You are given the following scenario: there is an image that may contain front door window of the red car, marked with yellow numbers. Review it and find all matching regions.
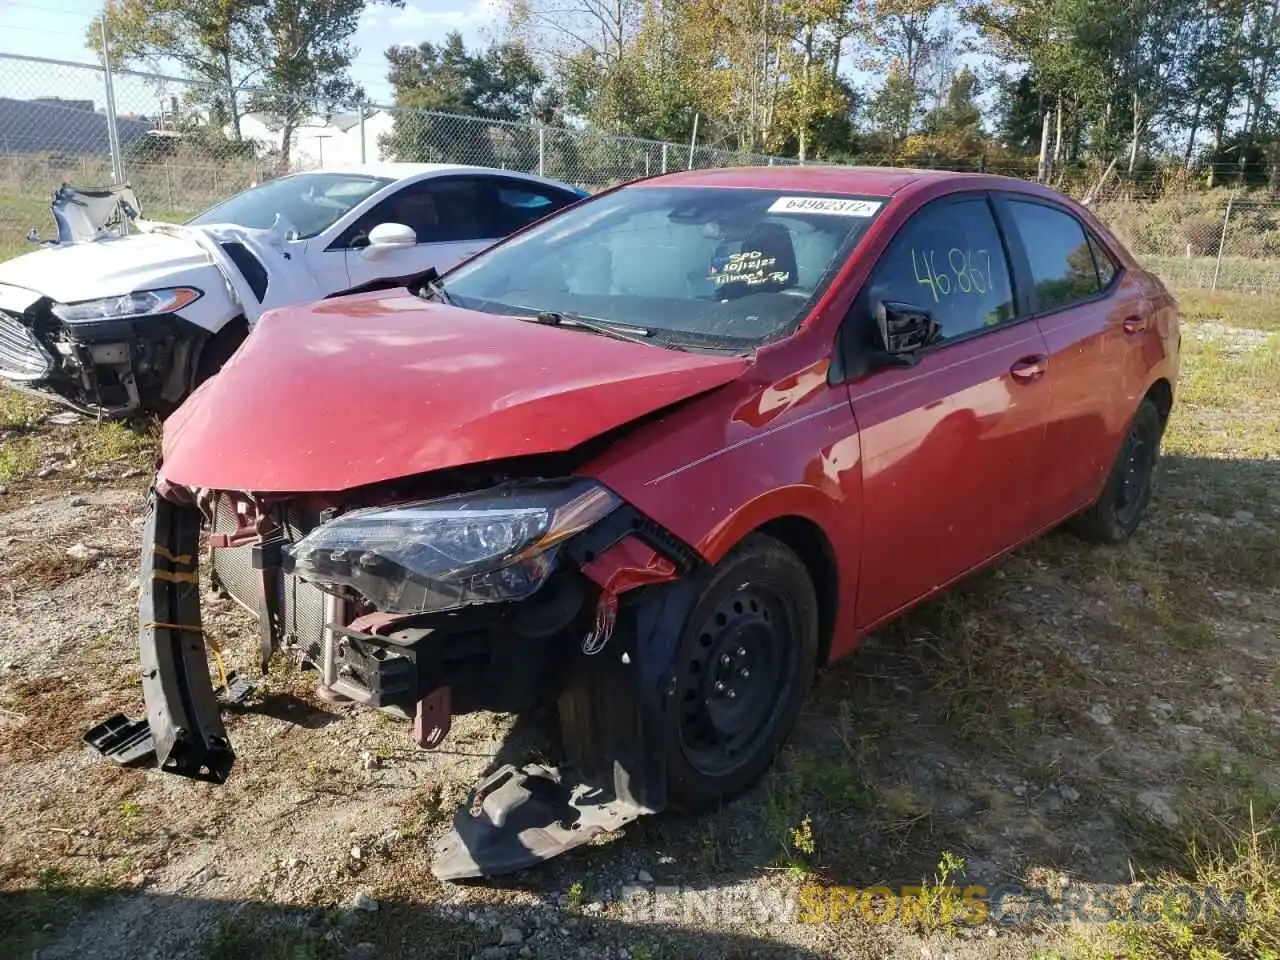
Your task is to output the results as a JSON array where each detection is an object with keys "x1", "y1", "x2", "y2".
[{"x1": 867, "y1": 196, "x2": 1014, "y2": 340}]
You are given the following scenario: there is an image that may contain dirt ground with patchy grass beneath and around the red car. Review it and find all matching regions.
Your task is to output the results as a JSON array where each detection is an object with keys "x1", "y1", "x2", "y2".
[{"x1": 0, "y1": 296, "x2": 1280, "y2": 960}]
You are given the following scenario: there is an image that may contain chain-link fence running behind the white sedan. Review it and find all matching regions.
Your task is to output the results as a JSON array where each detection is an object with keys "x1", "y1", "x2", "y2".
[{"x1": 0, "y1": 54, "x2": 797, "y2": 259}]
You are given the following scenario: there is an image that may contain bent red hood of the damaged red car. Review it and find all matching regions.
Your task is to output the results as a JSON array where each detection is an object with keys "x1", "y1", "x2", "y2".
[{"x1": 163, "y1": 292, "x2": 749, "y2": 493}]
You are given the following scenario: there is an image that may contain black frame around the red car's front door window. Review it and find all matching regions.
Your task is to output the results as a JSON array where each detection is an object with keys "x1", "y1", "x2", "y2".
[{"x1": 832, "y1": 189, "x2": 1034, "y2": 383}]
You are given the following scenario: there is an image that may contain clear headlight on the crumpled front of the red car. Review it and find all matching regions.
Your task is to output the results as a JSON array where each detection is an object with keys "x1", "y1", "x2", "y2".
[{"x1": 284, "y1": 480, "x2": 621, "y2": 613}]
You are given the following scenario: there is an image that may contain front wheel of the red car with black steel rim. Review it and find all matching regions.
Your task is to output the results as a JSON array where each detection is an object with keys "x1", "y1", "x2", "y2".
[{"x1": 666, "y1": 534, "x2": 818, "y2": 812}]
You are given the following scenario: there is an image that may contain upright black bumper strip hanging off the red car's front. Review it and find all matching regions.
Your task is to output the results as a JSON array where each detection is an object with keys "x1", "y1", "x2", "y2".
[{"x1": 138, "y1": 490, "x2": 236, "y2": 783}]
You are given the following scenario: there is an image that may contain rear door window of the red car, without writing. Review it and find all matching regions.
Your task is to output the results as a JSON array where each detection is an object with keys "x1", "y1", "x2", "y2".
[{"x1": 1006, "y1": 200, "x2": 1102, "y2": 312}]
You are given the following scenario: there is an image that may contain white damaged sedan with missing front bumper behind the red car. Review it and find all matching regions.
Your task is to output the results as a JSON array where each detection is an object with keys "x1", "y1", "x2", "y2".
[{"x1": 0, "y1": 164, "x2": 586, "y2": 417}]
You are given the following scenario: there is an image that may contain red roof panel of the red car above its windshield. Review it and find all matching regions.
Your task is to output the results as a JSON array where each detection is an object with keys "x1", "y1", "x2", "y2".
[{"x1": 637, "y1": 165, "x2": 1021, "y2": 197}]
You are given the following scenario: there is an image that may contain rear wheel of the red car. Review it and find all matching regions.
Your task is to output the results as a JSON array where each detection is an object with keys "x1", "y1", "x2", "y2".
[{"x1": 1068, "y1": 398, "x2": 1164, "y2": 544}]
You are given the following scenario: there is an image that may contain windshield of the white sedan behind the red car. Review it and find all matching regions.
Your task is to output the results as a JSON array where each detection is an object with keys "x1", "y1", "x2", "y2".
[{"x1": 187, "y1": 173, "x2": 394, "y2": 239}]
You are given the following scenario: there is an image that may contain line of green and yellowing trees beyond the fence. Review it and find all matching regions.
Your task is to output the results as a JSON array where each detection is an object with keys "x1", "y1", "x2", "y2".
[{"x1": 90, "y1": 0, "x2": 1280, "y2": 188}]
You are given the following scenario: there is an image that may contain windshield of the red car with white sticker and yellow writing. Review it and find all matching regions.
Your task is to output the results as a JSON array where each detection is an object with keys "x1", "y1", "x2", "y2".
[{"x1": 443, "y1": 186, "x2": 883, "y2": 348}]
